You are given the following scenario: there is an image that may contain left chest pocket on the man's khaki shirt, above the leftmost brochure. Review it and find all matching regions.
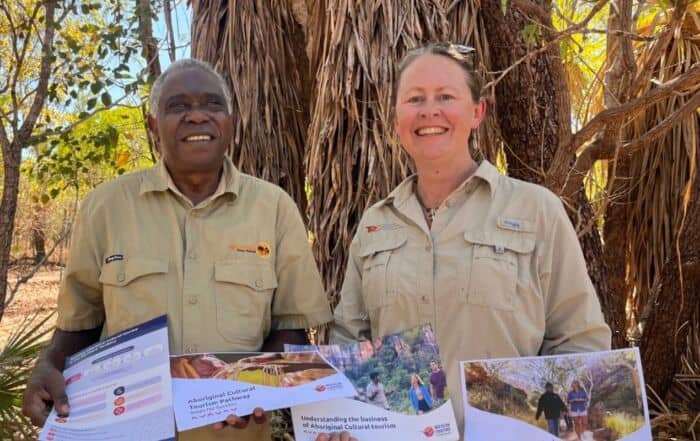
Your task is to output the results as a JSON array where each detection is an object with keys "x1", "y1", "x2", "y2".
[{"x1": 99, "y1": 257, "x2": 168, "y2": 333}]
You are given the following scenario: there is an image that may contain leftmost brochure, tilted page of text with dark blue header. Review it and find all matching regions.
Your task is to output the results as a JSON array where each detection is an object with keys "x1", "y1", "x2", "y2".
[{"x1": 39, "y1": 316, "x2": 175, "y2": 441}]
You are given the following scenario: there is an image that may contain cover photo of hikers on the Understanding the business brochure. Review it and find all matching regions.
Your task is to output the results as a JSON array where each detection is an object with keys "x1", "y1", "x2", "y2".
[{"x1": 285, "y1": 325, "x2": 449, "y2": 415}]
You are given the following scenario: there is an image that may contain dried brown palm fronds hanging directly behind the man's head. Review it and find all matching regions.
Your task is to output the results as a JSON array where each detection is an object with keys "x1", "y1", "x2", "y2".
[{"x1": 191, "y1": 0, "x2": 308, "y2": 210}]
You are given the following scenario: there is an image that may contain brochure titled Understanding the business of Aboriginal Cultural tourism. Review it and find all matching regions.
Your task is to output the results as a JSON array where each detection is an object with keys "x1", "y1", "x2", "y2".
[{"x1": 285, "y1": 325, "x2": 459, "y2": 441}]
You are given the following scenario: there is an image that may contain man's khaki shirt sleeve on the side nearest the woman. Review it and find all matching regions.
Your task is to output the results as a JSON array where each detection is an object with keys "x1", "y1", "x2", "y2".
[{"x1": 272, "y1": 193, "x2": 333, "y2": 330}]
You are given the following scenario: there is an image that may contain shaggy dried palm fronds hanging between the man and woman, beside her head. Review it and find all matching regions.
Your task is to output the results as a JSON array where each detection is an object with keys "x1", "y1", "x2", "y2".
[{"x1": 306, "y1": 0, "x2": 449, "y2": 305}]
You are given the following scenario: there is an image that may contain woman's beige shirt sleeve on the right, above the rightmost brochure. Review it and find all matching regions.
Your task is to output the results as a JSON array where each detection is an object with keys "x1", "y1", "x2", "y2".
[{"x1": 539, "y1": 195, "x2": 611, "y2": 354}]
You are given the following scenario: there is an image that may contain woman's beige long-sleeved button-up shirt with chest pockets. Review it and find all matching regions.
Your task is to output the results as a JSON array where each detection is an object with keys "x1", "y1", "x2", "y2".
[{"x1": 331, "y1": 161, "x2": 610, "y2": 431}]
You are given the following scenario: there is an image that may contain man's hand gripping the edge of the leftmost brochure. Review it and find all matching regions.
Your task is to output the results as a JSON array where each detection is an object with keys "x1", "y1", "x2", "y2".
[{"x1": 22, "y1": 360, "x2": 70, "y2": 427}]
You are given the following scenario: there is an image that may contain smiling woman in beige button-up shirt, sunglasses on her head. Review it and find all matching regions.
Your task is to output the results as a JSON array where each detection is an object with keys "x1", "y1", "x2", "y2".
[{"x1": 320, "y1": 44, "x2": 610, "y2": 440}]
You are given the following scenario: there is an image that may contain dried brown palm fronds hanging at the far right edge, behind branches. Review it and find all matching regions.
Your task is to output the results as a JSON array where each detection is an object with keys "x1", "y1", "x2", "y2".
[{"x1": 625, "y1": 6, "x2": 700, "y2": 336}]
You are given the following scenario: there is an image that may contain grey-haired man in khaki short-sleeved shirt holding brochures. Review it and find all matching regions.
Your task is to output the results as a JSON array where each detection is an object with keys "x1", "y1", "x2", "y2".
[{"x1": 23, "y1": 60, "x2": 331, "y2": 441}]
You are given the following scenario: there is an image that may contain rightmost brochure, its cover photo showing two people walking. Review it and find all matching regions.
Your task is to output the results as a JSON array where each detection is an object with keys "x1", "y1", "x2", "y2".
[{"x1": 460, "y1": 348, "x2": 652, "y2": 441}]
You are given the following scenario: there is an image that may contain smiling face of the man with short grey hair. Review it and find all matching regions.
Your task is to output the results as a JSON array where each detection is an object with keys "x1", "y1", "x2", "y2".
[{"x1": 148, "y1": 67, "x2": 233, "y2": 179}]
